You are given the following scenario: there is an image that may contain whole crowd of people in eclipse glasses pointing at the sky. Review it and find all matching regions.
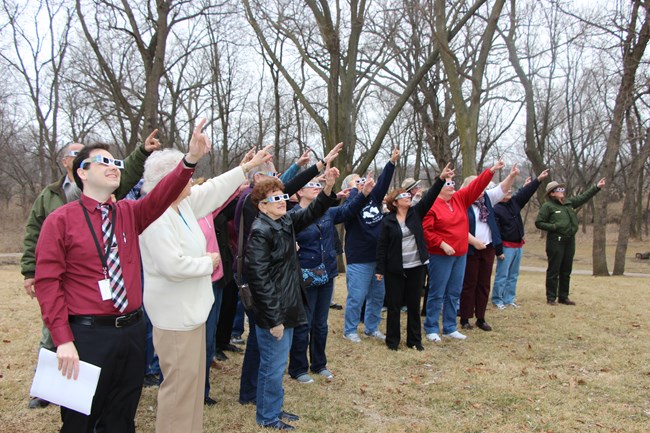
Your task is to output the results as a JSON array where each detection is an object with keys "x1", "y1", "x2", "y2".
[{"x1": 21, "y1": 121, "x2": 605, "y2": 433}]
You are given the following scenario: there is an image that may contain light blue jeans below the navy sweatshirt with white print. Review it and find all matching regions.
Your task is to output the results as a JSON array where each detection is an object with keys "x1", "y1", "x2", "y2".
[{"x1": 343, "y1": 260, "x2": 385, "y2": 335}]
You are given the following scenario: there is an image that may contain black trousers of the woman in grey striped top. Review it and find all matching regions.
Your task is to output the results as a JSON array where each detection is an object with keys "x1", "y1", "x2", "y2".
[{"x1": 384, "y1": 266, "x2": 427, "y2": 348}]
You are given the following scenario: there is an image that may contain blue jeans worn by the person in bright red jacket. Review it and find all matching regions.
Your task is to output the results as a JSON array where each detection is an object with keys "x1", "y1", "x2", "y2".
[{"x1": 424, "y1": 254, "x2": 467, "y2": 334}]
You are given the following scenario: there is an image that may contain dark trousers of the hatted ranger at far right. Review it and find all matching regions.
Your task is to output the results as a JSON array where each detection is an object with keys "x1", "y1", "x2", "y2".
[{"x1": 546, "y1": 233, "x2": 576, "y2": 301}]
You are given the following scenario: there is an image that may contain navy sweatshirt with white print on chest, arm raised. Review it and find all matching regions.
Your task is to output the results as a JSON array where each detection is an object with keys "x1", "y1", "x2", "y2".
[{"x1": 345, "y1": 161, "x2": 395, "y2": 264}]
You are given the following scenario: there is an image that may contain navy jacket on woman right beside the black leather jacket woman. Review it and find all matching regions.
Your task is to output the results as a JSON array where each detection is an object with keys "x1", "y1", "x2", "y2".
[{"x1": 290, "y1": 190, "x2": 368, "y2": 280}]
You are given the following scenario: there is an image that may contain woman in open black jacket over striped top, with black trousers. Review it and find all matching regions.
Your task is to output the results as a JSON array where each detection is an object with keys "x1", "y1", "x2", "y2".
[{"x1": 376, "y1": 164, "x2": 454, "y2": 351}]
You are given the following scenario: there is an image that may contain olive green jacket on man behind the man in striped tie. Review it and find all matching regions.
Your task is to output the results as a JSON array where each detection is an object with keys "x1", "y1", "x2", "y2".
[{"x1": 20, "y1": 146, "x2": 150, "y2": 278}]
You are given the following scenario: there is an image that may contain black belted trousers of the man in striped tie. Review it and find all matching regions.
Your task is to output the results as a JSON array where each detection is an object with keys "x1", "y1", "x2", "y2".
[{"x1": 61, "y1": 316, "x2": 147, "y2": 433}]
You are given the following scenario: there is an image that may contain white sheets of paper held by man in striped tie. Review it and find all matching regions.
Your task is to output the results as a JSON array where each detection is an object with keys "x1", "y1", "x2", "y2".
[{"x1": 29, "y1": 348, "x2": 102, "y2": 415}]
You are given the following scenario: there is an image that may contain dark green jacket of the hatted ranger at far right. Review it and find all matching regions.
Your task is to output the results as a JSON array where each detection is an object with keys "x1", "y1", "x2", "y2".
[{"x1": 535, "y1": 185, "x2": 600, "y2": 236}]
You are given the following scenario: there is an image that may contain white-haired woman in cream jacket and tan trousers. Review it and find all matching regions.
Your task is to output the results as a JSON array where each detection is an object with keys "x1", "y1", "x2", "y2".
[{"x1": 140, "y1": 149, "x2": 270, "y2": 433}]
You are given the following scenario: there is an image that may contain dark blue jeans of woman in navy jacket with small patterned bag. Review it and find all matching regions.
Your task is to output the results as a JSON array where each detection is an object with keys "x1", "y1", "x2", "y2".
[{"x1": 289, "y1": 279, "x2": 334, "y2": 379}]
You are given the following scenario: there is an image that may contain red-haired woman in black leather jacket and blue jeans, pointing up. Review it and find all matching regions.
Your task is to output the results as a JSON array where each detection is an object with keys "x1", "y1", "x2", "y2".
[{"x1": 246, "y1": 168, "x2": 339, "y2": 430}]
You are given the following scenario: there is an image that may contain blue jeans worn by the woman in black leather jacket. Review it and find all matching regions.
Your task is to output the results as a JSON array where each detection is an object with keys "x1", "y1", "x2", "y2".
[{"x1": 256, "y1": 326, "x2": 293, "y2": 425}]
